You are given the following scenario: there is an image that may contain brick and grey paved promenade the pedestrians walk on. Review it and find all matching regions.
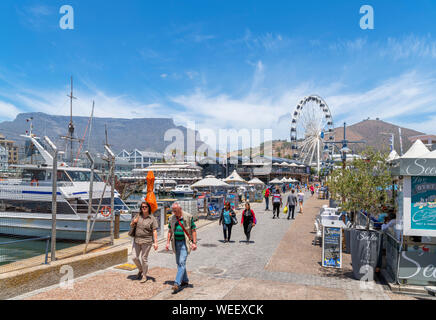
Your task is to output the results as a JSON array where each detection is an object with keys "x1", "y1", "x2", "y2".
[{"x1": 13, "y1": 192, "x2": 416, "y2": 300}]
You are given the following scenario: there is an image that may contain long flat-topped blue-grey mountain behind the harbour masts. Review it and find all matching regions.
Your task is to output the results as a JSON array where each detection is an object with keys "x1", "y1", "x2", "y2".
[{"x1": 0, "y1": 112, "x2": 201, "y2": 153}]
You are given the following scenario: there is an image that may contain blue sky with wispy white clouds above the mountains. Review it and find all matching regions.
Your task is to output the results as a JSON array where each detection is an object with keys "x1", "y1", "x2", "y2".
[{"x1": 0, "y1": 0, "x2": 436, "y2": 148}]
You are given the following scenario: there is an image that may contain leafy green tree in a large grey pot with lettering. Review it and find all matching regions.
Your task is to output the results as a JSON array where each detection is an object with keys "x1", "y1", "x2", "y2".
[{"x1": 329, "y1": 149, "x2": 391, "y2": 279}]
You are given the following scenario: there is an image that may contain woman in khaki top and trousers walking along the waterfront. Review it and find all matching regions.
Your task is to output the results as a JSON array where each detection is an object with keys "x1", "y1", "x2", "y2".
[{"x1": 129, "y1": 201, "x2": 158, "y2": 281}]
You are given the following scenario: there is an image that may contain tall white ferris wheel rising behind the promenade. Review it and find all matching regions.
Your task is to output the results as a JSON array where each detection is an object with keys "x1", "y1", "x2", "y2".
[{"x1": 291, "y1": 95, "x2": 335, "y2": 172}]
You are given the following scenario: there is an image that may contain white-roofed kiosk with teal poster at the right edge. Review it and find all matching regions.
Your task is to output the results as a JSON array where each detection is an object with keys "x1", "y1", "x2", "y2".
[{"x1": 386, "y1": 140, "x2": 436, "y2": 286}]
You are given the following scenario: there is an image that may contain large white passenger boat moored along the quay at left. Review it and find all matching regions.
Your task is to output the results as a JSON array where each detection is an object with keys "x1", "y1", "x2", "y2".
[{"x1": 0, "y1": 134, "x2": 131, "y2": 240}]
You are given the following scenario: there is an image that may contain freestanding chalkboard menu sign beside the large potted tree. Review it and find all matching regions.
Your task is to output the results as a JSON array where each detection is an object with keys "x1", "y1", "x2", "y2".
[{"x1": 322, "y1": 226, "x2": 342, "y2": 268}]
